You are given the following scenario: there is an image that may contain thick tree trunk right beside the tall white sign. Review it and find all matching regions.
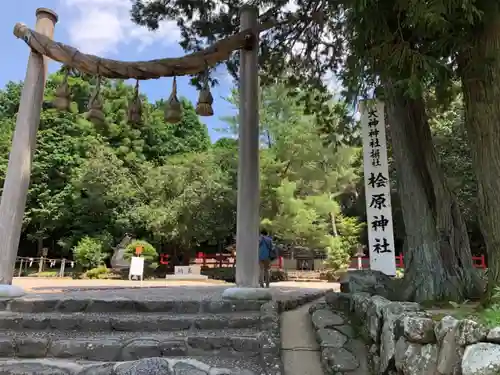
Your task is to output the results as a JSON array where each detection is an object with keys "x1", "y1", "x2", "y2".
[{"x1": 386, "y1": 89, "x2": 482, "y2": 302}]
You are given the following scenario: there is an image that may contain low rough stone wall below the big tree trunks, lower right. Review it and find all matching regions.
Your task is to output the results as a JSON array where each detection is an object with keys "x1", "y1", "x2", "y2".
[{"x1": 326, "y1": 293, "x2": 500, "y2": 375}]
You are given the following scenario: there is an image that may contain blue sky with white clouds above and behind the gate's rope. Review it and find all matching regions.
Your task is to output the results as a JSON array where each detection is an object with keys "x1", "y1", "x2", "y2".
[{"x1": 0, "y1": 0, "x2": 235, "y2": 140}]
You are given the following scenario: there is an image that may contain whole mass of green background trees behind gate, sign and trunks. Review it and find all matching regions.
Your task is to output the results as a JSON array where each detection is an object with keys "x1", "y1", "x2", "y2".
[{"x1": 0, "y1": 69, "x2": 482, "y2": 280}]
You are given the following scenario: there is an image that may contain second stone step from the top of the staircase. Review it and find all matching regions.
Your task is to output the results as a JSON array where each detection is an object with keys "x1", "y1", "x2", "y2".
[{"x1": 0, "y1": 311, "x2": 260, "y2": 332}]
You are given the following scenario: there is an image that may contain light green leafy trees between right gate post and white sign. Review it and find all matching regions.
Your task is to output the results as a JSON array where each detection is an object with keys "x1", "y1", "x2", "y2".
[{"x1": 226, "y1": 84, "x2": 363, "y2": 269}]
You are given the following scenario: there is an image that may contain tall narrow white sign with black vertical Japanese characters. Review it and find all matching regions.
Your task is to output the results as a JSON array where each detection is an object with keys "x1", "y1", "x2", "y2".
[{"x1": 360, "y1": 100, "x2": 396, "y2": 276}]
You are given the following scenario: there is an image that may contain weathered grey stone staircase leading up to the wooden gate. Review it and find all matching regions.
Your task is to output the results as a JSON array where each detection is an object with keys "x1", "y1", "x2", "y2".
[{"x1": 0, "y1": 294, "x2": 279, "y2": 375}]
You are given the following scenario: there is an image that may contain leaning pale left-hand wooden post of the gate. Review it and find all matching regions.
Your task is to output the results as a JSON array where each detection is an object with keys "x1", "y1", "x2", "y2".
[{"x1": 0, "y1": 8, "x2": 57, "y2": 284}]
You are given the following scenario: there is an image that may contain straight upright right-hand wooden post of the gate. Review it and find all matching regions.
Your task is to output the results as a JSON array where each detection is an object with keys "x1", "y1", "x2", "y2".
[{"x1": 236, "y1": 5, "x2": 260, "y2": 288}]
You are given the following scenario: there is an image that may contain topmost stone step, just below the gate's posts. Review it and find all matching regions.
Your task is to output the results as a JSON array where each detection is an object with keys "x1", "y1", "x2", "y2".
[{"x1": 0, "y1": 294, "x2": 265, "y2": 314}]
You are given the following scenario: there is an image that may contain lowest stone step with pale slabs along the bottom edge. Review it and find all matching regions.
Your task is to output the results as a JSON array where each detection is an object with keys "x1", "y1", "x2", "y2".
[{"x1": 0, "y1": 356, "x2": 266, "y2": 375}]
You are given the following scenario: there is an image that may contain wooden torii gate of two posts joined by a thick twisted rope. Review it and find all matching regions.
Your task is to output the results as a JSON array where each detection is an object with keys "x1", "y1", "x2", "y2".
[{"x1": 0, "y1": 6, "x2": 277, "y2": 298}]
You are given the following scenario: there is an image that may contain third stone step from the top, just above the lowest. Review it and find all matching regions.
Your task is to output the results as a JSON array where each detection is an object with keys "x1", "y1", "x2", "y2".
[{"x1": 0, "y1": 329, "x2": 265, "y2": 362}]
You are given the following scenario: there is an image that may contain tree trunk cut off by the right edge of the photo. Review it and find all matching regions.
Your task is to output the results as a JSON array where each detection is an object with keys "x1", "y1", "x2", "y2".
[{"x1": 458, "y1": 15, "x2": 500, "y2": 299}]
